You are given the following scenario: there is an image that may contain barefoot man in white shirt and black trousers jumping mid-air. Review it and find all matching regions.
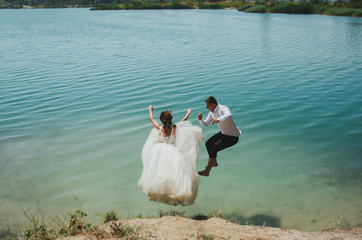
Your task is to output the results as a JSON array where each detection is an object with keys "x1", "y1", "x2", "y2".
[{"x1": 197, "y1": 97, "x2": 241, "y2": 177}]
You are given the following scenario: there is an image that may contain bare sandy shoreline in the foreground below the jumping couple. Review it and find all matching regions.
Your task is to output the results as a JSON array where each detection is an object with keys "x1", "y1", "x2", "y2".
[{"x1": 59, "y1": 216, "x2": 362, "y2": 240}]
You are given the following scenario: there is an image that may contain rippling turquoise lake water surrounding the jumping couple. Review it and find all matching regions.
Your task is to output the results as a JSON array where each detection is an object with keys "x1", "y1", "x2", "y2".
[{"x1": 0, "y1": 9, "x2": 362, "y2": 231}]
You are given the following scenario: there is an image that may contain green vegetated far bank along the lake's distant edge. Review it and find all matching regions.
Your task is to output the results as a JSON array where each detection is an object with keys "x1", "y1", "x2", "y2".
[{"x1": 0, "y1": 0, "x2": 362, "y2": 17}]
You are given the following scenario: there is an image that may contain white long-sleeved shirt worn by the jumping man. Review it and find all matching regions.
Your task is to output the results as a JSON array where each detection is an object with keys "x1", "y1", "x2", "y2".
[{"x1": 199, "y1": 104, "x2": 241, "y2": 137}]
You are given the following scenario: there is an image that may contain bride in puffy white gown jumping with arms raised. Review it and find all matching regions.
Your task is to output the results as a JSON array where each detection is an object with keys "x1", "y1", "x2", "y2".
[{"x1": 138, "y1": 105, "x2": 204, "y2": 206}]
